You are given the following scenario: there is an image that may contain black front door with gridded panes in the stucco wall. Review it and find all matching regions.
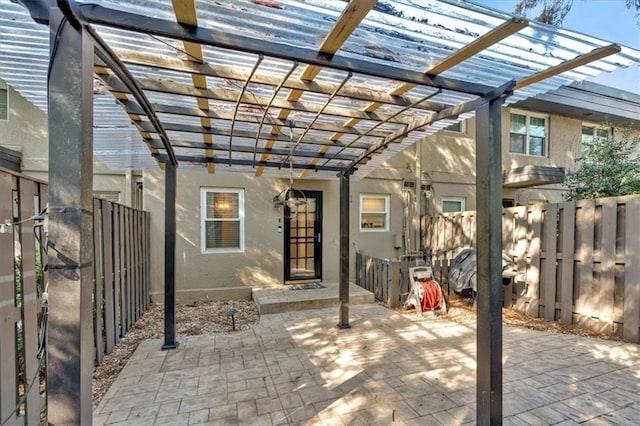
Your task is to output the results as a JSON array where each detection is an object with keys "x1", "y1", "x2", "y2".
[{"x1": 284, "y1": 191, "x2": 322, "y2": 283}]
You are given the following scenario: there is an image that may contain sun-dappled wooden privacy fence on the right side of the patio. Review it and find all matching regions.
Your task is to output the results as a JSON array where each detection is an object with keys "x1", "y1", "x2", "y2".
[{"x1": 421, "y1": 195, "x2": 640, "y2": 343}]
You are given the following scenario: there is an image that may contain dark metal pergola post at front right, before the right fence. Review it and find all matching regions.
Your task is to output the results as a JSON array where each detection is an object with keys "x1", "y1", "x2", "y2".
[{"x1": 476, "y1": 97, "x2": 503, "y2": 425}]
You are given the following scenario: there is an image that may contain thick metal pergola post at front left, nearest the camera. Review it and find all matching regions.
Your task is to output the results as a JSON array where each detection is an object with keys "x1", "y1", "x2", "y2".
[{"x1": 47, "y1": 7, "x2": 94, "y2": 425}]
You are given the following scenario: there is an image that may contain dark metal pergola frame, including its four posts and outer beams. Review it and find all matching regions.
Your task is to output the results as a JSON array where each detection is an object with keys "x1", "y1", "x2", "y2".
[{"x1": 20, "y1": 0, "x2": 604, "y2": 424}]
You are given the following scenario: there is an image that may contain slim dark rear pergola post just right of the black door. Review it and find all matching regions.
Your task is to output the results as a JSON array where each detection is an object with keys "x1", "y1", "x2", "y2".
[{"x1": 338, "y1": 173, "x2": 351, "y2": 329}]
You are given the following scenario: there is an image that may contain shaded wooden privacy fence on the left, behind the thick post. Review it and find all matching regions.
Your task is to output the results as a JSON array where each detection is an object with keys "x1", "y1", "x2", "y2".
[{"x1": 0, "y1": 169, "x2": 149, "y2": 425}]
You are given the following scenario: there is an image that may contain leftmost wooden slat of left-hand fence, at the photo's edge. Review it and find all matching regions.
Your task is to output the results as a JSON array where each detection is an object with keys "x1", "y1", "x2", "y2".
[{"x1": 0, "y1": 173, "x2": 20, "y2": 425}]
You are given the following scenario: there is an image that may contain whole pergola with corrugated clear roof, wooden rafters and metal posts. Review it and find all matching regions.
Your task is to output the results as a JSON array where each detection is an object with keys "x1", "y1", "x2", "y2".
[{"x1": 5, "y1": 0, "x2": 640, "y2": 424}]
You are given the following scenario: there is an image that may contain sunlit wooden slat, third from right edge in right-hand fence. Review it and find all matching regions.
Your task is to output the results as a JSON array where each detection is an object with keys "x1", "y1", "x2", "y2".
[{"x1": 576, "y1": 200, "x2": 596, "y2": 327}]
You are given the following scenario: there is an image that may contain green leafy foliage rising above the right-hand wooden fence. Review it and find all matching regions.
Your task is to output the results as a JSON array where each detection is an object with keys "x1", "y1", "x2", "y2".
[{"x1": 565, "y1": 129, "x2": 640, "y2": 200}]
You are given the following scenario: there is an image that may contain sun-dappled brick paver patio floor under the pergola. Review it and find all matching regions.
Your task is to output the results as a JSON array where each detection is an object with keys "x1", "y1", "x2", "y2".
[{"x1": 94, "y1": 304, "x2": 640, "y2": 425}]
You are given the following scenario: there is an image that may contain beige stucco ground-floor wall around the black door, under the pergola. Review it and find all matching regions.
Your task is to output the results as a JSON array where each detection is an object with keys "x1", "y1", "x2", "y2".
[{"x1": 144, "y1": 162, "x2": 412, "y2": 301}]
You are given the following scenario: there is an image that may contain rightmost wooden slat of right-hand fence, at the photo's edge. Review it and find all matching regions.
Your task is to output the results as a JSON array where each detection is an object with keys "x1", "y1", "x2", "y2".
[{"x1": 622, "y1": 197, "x2": 640, "y2": 343}]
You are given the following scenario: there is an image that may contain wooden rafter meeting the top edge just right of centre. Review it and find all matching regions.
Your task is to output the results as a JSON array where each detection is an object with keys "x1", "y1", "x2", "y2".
[{"x1": 256, "y1": 0, "x2": 376, "y2": 176}]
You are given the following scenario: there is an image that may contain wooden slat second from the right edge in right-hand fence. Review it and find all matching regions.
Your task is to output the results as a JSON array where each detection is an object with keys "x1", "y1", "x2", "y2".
[{"x1": 598, "y1": 198, "x2": 617, "y2": 331}]
